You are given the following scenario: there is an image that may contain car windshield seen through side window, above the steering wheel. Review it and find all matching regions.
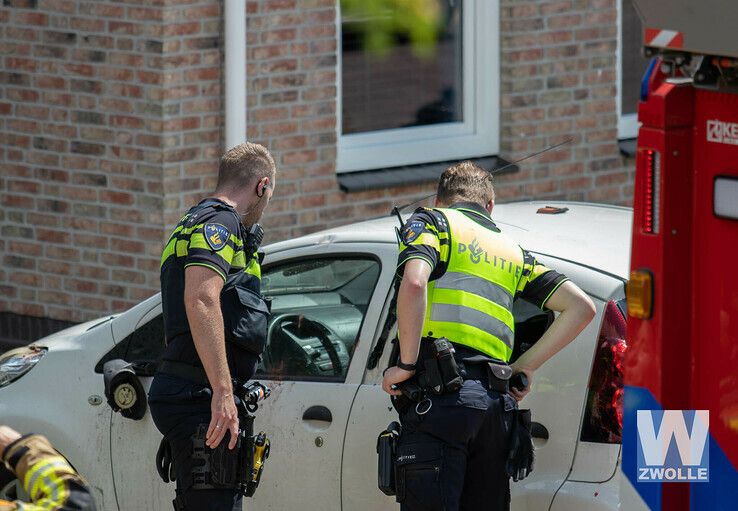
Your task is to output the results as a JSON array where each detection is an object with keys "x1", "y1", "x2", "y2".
[{"x1": 261, "y1": 259, "x2": 375, "y2": 297}]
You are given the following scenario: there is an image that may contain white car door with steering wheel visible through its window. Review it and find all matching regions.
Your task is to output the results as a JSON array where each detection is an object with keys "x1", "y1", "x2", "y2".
[{"x1": 247, "y1": 243, "x2": 396, "y2": 511}]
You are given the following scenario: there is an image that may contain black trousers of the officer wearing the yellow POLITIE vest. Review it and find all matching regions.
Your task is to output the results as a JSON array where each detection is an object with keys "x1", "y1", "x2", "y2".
[{"x1": 395, "y1": 380, "x2": 516, "y2": 511}]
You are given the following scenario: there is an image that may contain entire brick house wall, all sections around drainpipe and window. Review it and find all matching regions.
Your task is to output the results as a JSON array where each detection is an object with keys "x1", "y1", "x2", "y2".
[{"x1": 0, "y1": 0, "x2": 632, "y2": 328}]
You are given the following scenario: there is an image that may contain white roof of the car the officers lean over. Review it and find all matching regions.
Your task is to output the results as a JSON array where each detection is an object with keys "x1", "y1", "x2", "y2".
[{"x1": 265, "y1": 201, "x2": 633, "y2": 279}]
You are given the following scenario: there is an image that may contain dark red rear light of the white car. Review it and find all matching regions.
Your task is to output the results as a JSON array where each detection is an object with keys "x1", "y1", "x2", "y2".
[{"x1": 580, "y1": 300, "x2": 628, "y2": 443}]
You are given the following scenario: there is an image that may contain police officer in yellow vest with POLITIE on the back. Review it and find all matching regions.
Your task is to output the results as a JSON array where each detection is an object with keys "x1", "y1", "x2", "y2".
[{"x1": 382, "y1": 161, "x2": 595, "y2": 511}]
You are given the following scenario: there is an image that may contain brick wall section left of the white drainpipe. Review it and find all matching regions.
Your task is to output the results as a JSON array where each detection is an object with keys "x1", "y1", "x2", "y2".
[{"x1": 0, "y1": 0, "x2": 222, "y2": 321}]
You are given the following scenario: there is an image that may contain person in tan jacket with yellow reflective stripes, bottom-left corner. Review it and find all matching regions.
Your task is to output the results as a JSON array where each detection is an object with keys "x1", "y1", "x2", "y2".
[{"x1": 0, "y1": 426, "x2": 95, "y2": 511}]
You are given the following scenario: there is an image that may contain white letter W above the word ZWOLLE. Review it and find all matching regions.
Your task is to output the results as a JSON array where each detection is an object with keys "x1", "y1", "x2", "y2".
[{"x1": 637, "y1": 410, "x2": 710, "y2": 466}]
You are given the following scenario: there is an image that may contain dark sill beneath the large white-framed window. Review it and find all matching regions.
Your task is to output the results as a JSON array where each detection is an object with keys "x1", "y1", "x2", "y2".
[{"x1": 338, "y1": 156, "x2": 519, "y2": 193}]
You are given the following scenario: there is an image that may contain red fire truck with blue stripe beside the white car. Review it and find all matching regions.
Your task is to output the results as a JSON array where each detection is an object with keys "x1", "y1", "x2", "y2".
[{"x1": 621, "y1": 0, "x2": 738, "y2": 511}]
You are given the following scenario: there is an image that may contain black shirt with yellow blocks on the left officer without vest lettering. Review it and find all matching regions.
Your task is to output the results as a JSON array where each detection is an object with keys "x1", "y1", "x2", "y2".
[{"x1": 161, "y1": 198, "x2": 254, "y2": 374}]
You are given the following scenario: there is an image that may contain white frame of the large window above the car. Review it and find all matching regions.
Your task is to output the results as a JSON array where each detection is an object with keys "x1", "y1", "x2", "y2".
[{"x1": 336, "y1": 0, "x2": 500, "y2": 173}]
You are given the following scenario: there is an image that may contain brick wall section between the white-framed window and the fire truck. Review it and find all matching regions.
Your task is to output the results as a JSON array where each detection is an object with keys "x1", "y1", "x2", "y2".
[{"x1": 498, "y1": 0, "x2": 634, "y2": 204}]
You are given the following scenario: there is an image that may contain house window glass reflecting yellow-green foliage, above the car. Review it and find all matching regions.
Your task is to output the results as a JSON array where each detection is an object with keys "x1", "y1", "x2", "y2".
[{"x1": 341, "y1": 0, "x2": 463, "y2": 135}]
